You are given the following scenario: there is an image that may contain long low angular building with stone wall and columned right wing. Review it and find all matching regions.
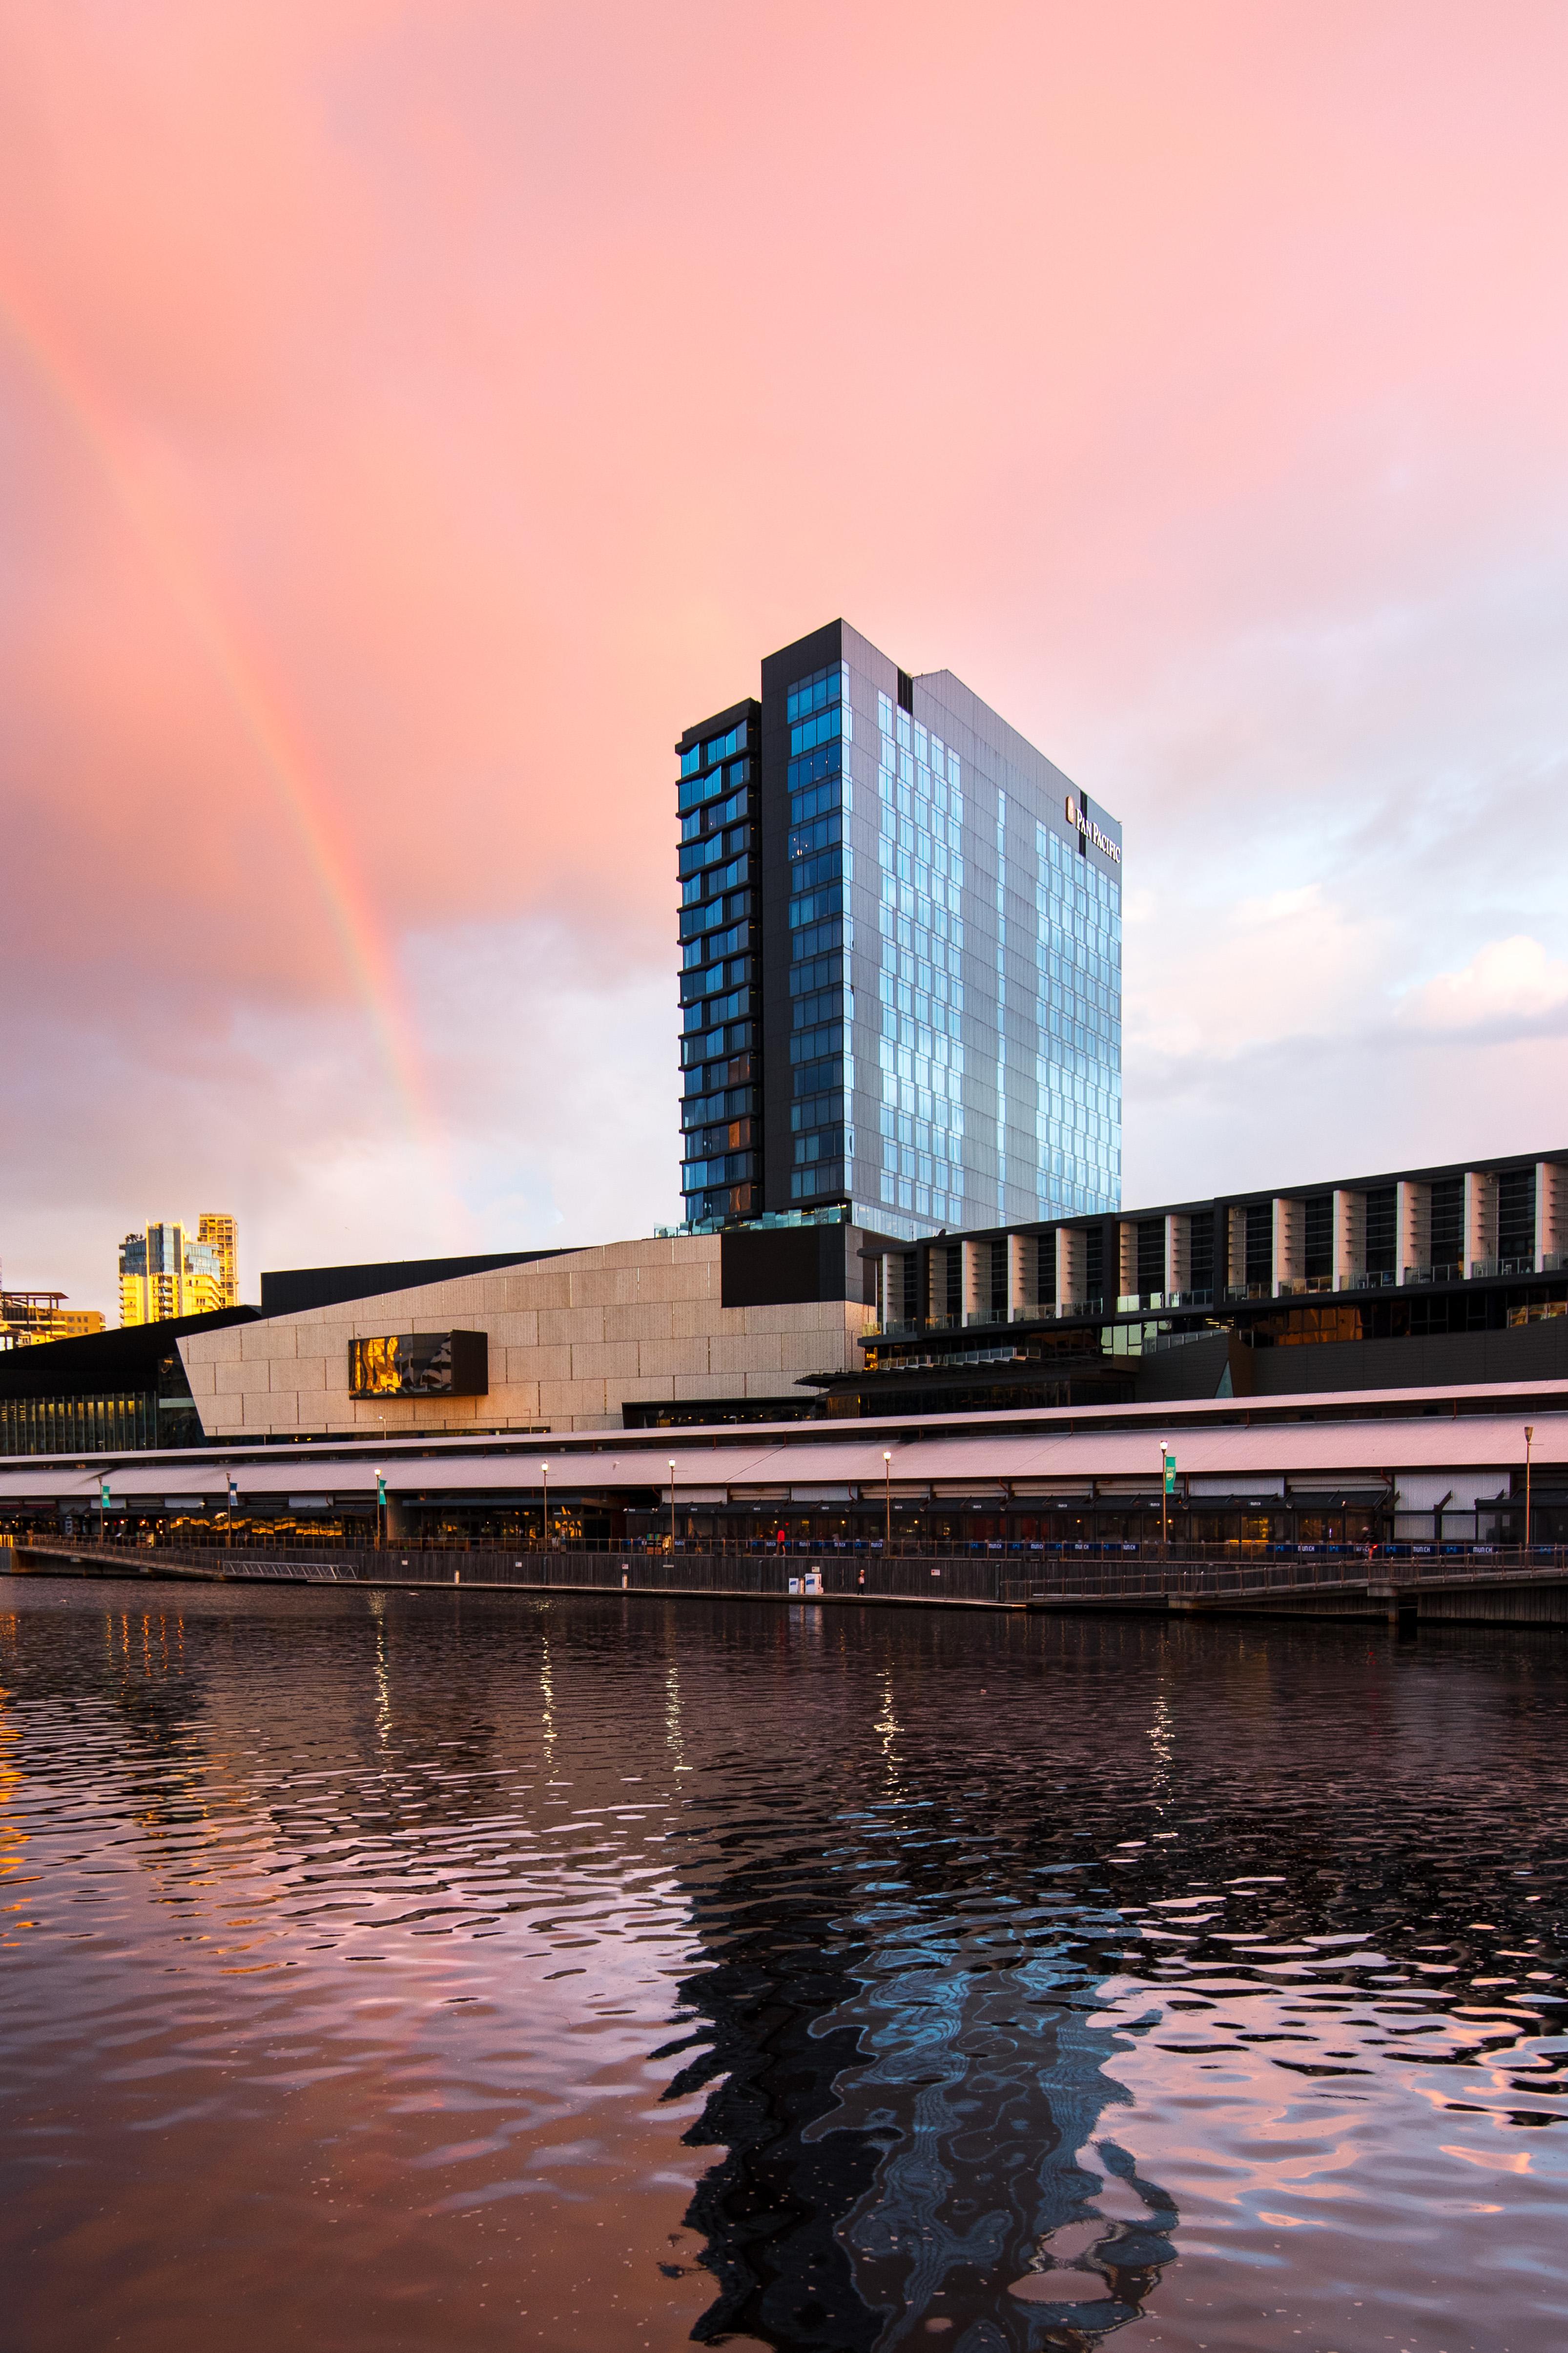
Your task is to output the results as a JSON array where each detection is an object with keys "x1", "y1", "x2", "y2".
[{"x1": 0, "y1": 1150, "x2": 1568, "y2": 1454}]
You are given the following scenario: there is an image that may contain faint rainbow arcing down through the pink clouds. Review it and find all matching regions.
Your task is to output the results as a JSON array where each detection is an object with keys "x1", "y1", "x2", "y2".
[{"x1": 0, "y1": 261, "x2": 447, "y2": 1169}]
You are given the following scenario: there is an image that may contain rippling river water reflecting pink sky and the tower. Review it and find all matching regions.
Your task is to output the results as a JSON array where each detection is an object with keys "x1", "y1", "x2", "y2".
[{"x1": 0, "y1": 1579, "x2": 1568, "y2": 2353}]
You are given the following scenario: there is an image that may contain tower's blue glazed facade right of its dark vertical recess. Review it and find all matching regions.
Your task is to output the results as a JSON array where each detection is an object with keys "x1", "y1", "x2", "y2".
[{"x1": 787, "y1": 628, "x2": 1121, "y2": 1238}]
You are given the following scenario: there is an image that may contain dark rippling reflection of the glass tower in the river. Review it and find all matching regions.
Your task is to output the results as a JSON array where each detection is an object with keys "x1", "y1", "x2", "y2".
[{"x1": 670, "y1": 1760, "x2": 1178, "y2": 2353}]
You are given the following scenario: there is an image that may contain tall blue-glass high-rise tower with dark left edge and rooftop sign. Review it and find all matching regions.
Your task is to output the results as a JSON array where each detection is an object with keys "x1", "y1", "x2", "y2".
[{"x1": 677, "y1": 621, "x2": 1121, "y2": 1240}]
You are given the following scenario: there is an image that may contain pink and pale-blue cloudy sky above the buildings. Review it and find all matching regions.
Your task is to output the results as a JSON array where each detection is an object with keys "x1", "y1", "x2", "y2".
[{"x1": 0, "y1": 0, "x2": 1568, "y2": 1306}]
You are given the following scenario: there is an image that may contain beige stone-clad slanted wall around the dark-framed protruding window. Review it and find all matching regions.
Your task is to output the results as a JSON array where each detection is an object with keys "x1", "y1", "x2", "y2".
[{"x1": 179, "y1": 1235, "x2": 872, "y2": 1437}]
